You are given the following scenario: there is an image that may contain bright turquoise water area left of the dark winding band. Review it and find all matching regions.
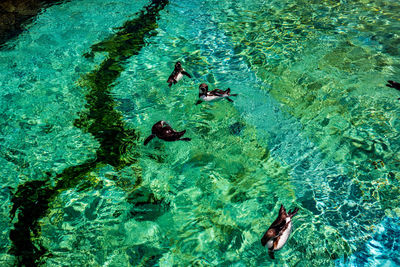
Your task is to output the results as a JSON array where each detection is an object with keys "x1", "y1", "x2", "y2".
[{"x1": 0, "y1": 1, "x2": 146, "y2": 187}]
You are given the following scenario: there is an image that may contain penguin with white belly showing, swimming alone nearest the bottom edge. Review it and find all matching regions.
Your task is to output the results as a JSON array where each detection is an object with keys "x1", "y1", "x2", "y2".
[{"x1": 261, "y1": 205, "x2": 299, "y2": 259}]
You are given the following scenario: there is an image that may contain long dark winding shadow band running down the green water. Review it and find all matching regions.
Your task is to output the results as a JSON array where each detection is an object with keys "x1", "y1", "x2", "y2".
[{"x1": 9, "y1": 0, "x2": 168, "y2": 266}]
